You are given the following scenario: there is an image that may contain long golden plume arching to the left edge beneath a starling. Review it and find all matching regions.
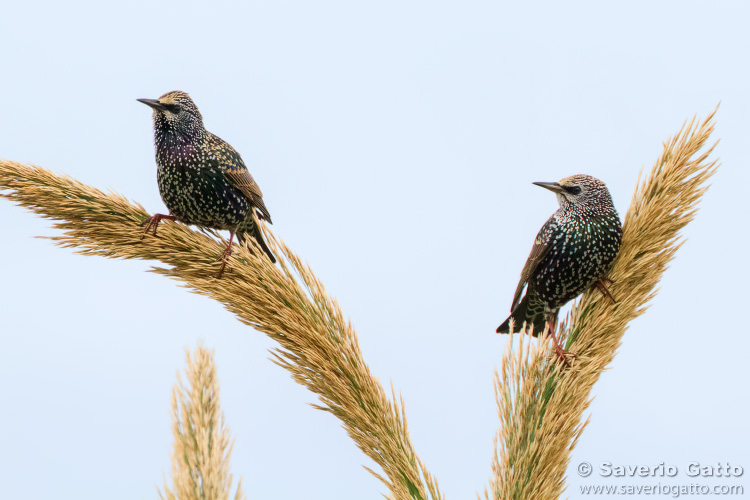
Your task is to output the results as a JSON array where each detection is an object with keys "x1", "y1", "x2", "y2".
[{"x1": 0, "y1": 160, "x2": 441, "y2": 500}]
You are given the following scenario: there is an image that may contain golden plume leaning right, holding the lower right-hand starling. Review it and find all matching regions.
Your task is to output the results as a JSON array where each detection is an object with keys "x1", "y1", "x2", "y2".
[{"x1": 485, "y1": 110, "x2": 718, "y2": 500}]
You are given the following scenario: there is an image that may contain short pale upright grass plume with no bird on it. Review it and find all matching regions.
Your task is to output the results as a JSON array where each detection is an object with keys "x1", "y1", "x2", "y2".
[{"x1": 159, "y1": 345, "x2": 245, "y2": 500}]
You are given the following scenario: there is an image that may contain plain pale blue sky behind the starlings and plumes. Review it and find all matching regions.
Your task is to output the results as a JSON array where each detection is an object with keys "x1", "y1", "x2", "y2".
[{"x1": 0, "y1": 0, "x2": 750, "y2": 500}]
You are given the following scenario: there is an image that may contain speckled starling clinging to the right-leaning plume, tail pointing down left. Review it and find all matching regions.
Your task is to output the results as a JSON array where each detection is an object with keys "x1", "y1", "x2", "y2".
[{"x1": 497, "y1": 175, "x2": 622, "y2": 363}]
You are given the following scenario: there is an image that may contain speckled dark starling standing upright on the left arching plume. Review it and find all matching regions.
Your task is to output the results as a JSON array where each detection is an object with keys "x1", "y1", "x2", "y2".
[{"x1": 138, "y1": 90, "x2": 276, "y2": 276}]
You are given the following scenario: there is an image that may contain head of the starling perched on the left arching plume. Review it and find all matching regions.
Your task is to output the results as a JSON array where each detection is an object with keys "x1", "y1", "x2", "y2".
[{"x1": 138, "y1": 90, "x2": 204, "y2": 137}]
